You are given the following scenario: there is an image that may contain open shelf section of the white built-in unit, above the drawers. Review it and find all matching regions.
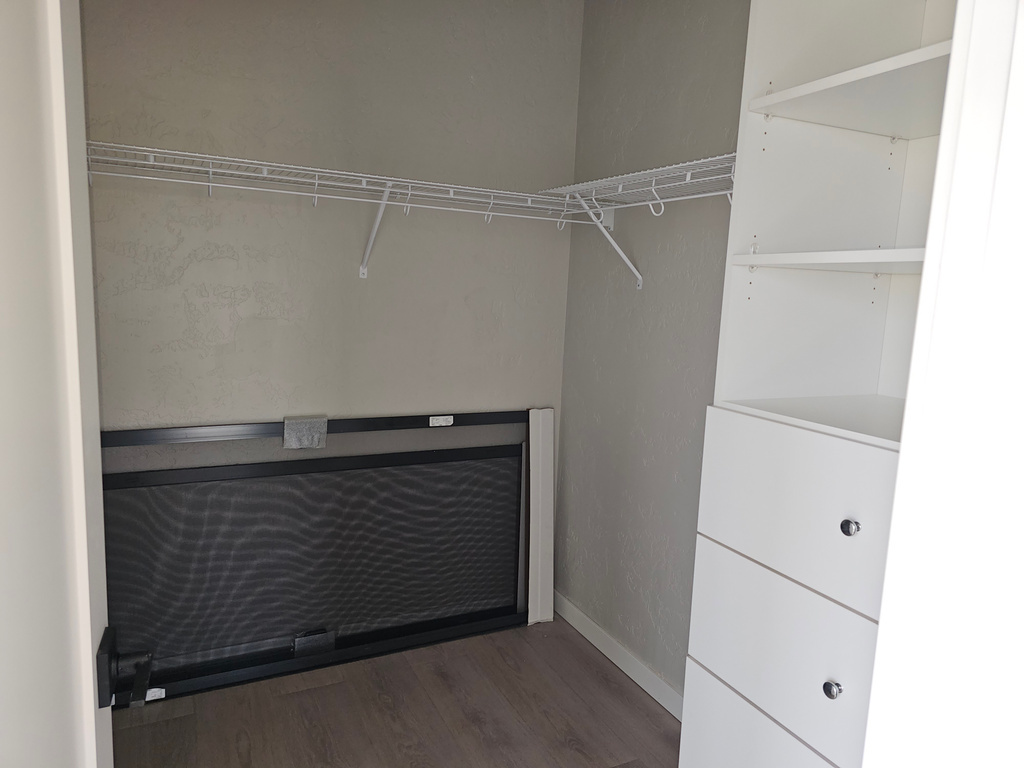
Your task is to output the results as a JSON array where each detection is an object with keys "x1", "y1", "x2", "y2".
[{"x1": 716, "y1": 0, "x2": 951, "y2": 447}]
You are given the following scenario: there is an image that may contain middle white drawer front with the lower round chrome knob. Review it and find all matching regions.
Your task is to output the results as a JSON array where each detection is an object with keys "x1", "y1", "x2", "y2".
[{"x1": 689, "y1": 536, "x2": 878, "y2": 768}]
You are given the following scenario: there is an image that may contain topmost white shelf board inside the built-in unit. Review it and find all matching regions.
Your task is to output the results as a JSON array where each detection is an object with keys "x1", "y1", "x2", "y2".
[{"x1": 750, "y1": 40, "x2": 952, "y2": 138}]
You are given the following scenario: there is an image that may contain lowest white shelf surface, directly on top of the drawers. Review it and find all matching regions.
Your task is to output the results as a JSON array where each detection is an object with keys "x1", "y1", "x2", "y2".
[{"x1": 716, "y1": 394, "x2": 905, "y2": 451}]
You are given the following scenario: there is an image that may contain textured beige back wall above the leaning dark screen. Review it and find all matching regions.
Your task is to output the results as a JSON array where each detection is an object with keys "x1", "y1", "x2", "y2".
[{"x1": 84, "y1": 0, "x2": 583, "y2": 429}]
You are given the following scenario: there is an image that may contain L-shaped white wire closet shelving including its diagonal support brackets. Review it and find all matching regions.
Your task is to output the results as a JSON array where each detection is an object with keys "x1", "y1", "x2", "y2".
[{"x1": 86, "y1": 141, "x2": 736, "y2": 289}]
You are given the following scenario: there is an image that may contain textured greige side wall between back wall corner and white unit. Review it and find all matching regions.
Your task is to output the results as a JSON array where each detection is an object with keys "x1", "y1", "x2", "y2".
[{"x1": 555, "y1": 0, "x2": 749, "y2": 689}]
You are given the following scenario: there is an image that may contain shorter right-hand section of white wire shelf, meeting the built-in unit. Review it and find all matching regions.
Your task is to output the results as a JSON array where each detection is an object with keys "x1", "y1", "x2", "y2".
[{"x1": 544, "y1": 153, "x2": 736, "y2": 216}]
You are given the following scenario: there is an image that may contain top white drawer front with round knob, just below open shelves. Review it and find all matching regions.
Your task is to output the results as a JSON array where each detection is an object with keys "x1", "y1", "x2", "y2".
[{"x1": 697, "y1": 408, "x2": 898, "y2": 618}]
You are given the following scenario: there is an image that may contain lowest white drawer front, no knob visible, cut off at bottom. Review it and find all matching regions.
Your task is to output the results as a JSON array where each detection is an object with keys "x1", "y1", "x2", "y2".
[{"x1": 679, "y1": 658, "x2": 829, "y2": 768}]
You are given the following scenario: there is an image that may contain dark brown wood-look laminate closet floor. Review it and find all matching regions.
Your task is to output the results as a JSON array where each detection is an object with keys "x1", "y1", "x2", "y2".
[{"x1": 114, "y1": 617, "x2": 679, "y2": 768}]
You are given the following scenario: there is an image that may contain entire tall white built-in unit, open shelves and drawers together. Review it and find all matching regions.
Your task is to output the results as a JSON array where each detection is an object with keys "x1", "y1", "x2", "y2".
[{"x1": 680, "y1": 0, "x2": 954, "y2": 768}]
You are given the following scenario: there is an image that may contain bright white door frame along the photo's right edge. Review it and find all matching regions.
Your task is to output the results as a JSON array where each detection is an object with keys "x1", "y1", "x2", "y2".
[{"x1": 864, "y1": 0, "x2": 1024, "y2": 768}]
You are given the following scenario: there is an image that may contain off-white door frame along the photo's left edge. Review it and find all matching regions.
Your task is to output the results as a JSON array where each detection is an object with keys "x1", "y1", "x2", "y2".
[{"x1": 0, "y1": 0, "x2": 113, "y2": 768}]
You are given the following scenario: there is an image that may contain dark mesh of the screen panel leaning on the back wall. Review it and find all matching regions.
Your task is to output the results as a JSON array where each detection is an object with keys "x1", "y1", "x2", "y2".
[{"x1": 103, "y1": 457, "x2": 521, "y2": 664}]
